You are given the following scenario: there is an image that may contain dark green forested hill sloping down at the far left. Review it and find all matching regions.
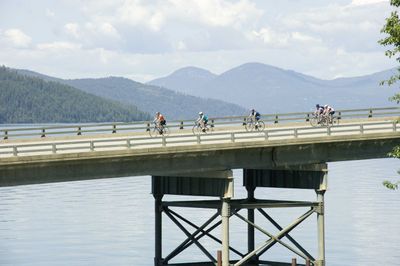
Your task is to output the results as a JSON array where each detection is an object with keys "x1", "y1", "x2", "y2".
[{"x1": 0, "y1": 67, "x2": 150, "y2": 123}]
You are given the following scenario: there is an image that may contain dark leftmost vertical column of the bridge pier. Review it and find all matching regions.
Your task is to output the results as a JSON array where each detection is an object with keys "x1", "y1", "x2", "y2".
[{"x1": 153, "y1": 194, "x2": 163, "y2": 266}]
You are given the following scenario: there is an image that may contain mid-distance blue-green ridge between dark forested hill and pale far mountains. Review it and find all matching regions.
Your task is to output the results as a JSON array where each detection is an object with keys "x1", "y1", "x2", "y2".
[{"x1": 17, "y1": 70, "x2": 246, "y2": 119}]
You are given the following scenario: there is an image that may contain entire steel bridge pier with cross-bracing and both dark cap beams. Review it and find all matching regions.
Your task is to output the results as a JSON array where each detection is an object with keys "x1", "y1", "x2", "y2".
[{"x1": 152, "y1": 164, "x2": 327, "y2": 266}]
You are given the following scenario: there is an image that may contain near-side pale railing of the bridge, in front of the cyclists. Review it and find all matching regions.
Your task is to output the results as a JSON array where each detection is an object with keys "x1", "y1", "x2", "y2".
[{"x1": 0, "y1": 121, "x2": 400, "y2": 158}]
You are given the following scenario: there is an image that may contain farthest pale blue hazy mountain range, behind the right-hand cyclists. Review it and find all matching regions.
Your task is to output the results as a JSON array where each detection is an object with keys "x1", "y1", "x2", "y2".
[{"x1": 149, "y1": 63, "x2": 395, "y2": 113}]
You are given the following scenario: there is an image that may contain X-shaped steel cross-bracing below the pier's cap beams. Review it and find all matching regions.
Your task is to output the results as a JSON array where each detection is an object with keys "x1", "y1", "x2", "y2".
[{"x1": 155, "y1": 199, "x2": 320, "y2": 266}]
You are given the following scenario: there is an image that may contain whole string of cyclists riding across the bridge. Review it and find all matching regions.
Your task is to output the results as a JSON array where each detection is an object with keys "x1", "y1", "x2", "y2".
[{"x1": 153, "y1": 104, "x2": 335, "y2": 135}]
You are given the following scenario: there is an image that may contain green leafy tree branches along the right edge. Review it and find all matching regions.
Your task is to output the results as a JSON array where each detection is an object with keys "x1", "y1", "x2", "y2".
[{"x1": 379, "y1": 0, "x2": 400, "y2": 190}]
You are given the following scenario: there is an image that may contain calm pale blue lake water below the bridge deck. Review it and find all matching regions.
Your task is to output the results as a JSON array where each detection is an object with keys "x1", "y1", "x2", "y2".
[{"x1": 0, "y1": 159, "x2": 400, "y2": 266}]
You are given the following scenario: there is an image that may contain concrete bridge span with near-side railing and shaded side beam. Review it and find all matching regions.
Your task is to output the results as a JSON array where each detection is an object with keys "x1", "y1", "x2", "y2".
[{"x1": 0, "y1": 117, "x2": 400, "y2": 186}]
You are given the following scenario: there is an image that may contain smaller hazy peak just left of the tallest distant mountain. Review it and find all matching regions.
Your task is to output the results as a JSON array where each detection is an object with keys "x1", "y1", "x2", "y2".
[{"x1": 147, "y1": 67, "x2": 217, "y2": 96}]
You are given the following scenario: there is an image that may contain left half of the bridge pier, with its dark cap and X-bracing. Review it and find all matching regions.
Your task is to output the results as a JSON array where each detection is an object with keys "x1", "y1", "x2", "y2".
[{"x1": 152, "y1": 170, "x2": 233, "y2": 266}]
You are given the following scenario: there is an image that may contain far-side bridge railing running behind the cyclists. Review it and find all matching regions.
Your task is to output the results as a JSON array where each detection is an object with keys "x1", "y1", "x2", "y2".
[{"x1": 0, "y1": 107, "x2": 400, "y2": 139}]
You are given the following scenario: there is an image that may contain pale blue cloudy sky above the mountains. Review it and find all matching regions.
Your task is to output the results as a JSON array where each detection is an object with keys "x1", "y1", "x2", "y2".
[{"x1": 0, "y1": 0, "x2": 396, "y2": 82}]
